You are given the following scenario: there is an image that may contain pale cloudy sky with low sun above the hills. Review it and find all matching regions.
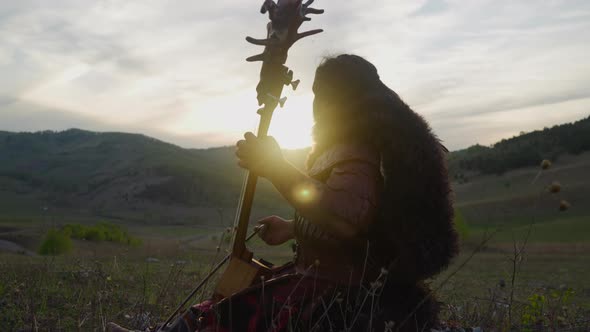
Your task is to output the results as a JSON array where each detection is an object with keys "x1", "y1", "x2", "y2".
[{"x1": 0, "y1": 0, "x2": 590, "y2": 150}]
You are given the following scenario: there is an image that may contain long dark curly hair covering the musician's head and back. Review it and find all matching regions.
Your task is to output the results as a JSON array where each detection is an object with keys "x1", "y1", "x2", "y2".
[{"x1": 307, "y1": 54, "x2": 458, "y2": 283}]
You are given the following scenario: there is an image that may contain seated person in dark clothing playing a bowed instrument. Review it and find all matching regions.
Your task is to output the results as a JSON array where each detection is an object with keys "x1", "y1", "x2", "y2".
[{"x1": 112, "y1": 54, "x2": 457, "y2": 331}]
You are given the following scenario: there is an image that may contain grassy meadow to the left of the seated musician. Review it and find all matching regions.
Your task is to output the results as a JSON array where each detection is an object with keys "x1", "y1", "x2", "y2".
[{"x1": 0, "y1": 222, "x2": 300, "y2": 331}]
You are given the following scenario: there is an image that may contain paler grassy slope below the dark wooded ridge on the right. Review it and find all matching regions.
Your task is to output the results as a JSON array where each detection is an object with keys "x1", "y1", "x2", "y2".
[{"x1": 453, "y1": 153, "x2": 590, "y2": 230}]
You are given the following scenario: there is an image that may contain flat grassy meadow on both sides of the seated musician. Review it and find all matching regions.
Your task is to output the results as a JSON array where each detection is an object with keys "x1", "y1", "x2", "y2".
[{"x1": 0, "y1": 217, "x2": 590, "y2": 331}]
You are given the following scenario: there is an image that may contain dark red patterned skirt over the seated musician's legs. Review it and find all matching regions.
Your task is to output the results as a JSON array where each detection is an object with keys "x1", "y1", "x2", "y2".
[{"x1": 164, "y1": 263, "x2": 342, "y2": 332}]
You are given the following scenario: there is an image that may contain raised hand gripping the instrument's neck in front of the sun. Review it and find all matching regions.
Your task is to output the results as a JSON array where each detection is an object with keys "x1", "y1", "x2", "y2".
[{"x1": 236, "y1": 132, "x2": 285, "y2": 178}]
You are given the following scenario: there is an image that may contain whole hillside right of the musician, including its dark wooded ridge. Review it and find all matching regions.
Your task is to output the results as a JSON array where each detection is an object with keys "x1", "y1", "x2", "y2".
[{"x1": 449, "y1": 117, "x2": 590, "y2": 233}]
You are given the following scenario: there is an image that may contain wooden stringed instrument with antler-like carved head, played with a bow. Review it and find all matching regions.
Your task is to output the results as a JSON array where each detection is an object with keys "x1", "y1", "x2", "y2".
[{"x1": 213, "y1": 0, "x2": 324, "y2": 300}]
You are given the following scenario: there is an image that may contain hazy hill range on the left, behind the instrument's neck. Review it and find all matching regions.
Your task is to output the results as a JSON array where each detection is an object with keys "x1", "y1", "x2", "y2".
[{"x1": 0, "y1": 129, "x2": 305, "y2": 224}]
